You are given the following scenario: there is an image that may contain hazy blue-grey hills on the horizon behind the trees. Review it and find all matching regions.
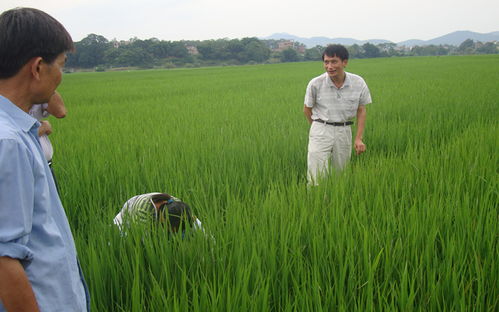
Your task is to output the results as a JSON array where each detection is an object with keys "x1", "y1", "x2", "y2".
[{"x1": 260, "y1": 31, "x2": 499, "y2": 48}]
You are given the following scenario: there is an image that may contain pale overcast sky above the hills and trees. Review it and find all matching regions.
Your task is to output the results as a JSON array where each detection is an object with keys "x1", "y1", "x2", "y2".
[{"x1": 0, "y1": 0, "x2": 499, "y2": 42}]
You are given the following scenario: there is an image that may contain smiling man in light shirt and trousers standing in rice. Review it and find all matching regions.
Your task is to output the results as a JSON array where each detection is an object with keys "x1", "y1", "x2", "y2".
[{"x1": 303, "y1": 44, "x2": 371, "y2": 185}]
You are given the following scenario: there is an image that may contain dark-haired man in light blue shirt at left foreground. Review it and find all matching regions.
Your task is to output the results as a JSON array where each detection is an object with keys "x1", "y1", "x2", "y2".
[{"x1": 0, "y1": 8, "x2": 89, "y2": 312}]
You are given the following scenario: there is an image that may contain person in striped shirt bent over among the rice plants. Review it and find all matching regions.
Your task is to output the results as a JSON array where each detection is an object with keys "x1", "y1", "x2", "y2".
[{"x1": 114, "y1": 193, "x2": 204, "y2": 237}]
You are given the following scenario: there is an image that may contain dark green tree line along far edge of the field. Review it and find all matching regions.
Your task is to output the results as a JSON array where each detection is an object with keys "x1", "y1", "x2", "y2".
[{"x1": 66, "y1": 34, "x2": 499, "y2": 71}]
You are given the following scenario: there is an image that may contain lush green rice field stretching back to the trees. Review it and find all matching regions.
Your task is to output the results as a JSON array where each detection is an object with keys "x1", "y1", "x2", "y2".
[{"x1": 50, "y1": 55, "x2": 499, "y2": 311}]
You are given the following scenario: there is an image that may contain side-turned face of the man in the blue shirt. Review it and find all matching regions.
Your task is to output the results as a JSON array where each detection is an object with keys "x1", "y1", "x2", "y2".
[{"x1": 39, "y1": 53, "x2": 66, "y2": 103}]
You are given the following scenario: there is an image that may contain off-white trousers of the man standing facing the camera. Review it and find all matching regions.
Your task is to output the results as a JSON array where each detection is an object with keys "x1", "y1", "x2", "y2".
[{"x1": 307, "y1": 122, "x2": 352, "y2": 185}]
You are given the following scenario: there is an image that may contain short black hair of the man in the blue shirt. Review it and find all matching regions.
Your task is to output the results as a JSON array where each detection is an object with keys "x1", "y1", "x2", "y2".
[{"x1": 0, "y1": 8, "x2": 74, "y2": 79}]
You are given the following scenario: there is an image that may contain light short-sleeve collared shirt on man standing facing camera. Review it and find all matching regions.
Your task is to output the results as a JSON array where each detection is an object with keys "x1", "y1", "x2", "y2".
[{"x1": 305, "y1": 72, "x2": 372, "y2": 122}]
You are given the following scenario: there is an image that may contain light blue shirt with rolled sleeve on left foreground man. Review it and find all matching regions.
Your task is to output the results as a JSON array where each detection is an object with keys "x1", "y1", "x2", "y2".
[{"x1": 0, "y1": 95, "x2": 88, "y2": 312}]
